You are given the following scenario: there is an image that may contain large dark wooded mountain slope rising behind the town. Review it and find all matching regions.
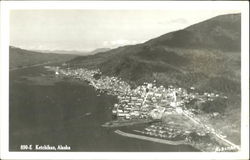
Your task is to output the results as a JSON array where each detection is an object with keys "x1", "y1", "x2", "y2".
[{"x1": 69, "y1": 14, "x2": 241, "y2": 93}]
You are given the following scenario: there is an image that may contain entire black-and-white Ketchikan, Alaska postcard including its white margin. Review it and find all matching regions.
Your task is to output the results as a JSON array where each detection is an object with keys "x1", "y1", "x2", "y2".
[{"x1": 1, "y1": 2, "x2": 249, "y2": 159}]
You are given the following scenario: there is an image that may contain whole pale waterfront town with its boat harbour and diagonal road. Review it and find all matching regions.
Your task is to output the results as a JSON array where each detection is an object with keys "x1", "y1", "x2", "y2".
[{"x1": 45, "y1": 66, "x2": 238, "y2": 151}]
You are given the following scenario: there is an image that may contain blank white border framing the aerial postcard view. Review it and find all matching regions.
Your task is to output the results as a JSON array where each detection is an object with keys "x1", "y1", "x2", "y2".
[{"x1": 0, "y1": 1, "x2": 249, "y2": 159}]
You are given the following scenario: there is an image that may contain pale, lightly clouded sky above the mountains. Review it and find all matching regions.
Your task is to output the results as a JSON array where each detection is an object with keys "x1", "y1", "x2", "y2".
[{"x1": 10, "y1": 10, "x2": 237, "y2": 51}]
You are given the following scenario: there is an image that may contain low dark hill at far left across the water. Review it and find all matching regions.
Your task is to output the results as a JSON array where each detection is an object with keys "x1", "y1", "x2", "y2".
[{"x1": 9, "y1": 46, "x2": 76, "y2": 69}]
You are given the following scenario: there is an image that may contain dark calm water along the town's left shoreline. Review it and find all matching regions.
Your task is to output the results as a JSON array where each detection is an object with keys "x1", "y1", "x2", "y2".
[{"x1": 9, "y1": 67, "x2": 197, "y2": 152}]
